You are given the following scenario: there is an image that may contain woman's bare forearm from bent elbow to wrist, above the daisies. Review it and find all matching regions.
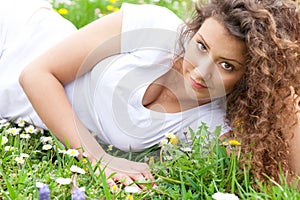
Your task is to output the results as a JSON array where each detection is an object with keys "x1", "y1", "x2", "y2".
[{"x1": 20, "y1": 70, "x2": 109, "y2": 160}]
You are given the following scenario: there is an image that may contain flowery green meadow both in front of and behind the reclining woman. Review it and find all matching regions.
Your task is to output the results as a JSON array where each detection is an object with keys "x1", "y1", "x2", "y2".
[{"x1": 0, "y1": 0, "x2": 300, "y2": 200}]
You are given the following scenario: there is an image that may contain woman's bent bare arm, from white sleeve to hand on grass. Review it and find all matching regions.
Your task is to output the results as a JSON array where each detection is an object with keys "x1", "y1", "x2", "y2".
[{"x1": 20, "y1": 9, "x2": 150, "y2": 188}]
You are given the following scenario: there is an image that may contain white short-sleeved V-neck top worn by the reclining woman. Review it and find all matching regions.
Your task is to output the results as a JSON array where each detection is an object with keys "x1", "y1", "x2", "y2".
[{"x1": 65, "y1": 4, "x2": 229, "y2": 151}]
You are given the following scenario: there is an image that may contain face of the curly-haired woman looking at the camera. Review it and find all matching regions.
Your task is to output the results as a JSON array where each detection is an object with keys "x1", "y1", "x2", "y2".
[{"x1": 183, "y1": 18, "x2": 246, "y2": 102}]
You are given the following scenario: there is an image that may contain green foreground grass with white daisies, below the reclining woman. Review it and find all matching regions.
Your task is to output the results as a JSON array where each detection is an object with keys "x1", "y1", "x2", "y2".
[{"x1": 0, "y1": 119, "x2": 300, "y2": 200}]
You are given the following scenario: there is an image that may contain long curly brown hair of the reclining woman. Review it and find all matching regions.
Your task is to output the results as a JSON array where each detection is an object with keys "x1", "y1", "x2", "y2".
[{"x1": 180, "y1": 0, "x2": 300, "y2": 184}]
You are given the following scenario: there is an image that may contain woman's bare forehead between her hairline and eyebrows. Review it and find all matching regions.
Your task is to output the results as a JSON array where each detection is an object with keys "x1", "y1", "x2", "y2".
[{"x1": 195, "y1": 18, "x2": 246, "y2": 62}]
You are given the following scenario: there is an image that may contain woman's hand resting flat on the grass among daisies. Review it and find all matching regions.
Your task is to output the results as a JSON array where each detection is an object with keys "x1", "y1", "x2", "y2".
[{"x1": 92, "y1": 154, "x2": 154, "y2": 190}]
